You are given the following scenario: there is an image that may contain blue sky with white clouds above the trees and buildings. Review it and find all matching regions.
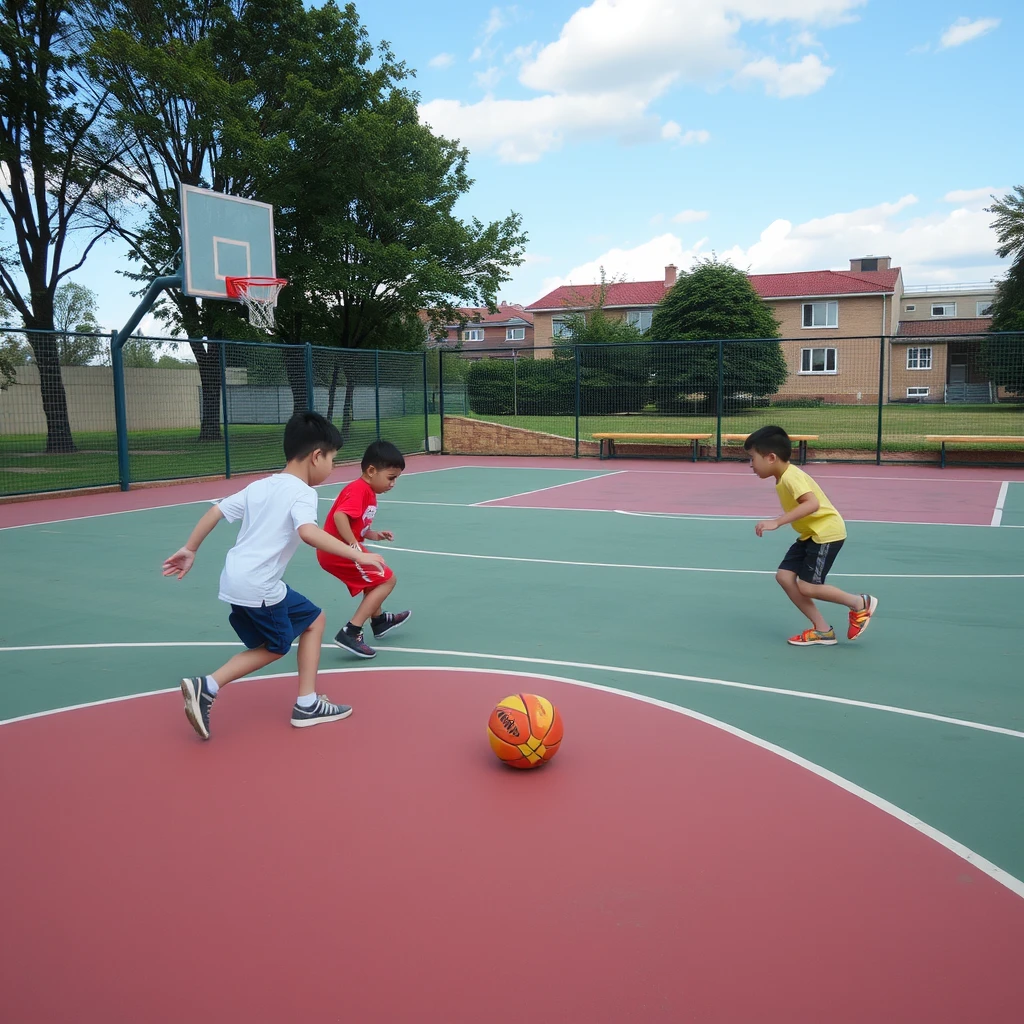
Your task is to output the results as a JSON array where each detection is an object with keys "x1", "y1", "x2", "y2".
[{"x1": 18, "y1": 0, "x2": 1024, "y2": 328}]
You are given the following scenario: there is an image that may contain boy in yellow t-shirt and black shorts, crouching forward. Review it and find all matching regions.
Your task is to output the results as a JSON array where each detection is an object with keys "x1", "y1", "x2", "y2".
[{"x1": 743, "y1": 427, "x2": 879, "y2": 647}]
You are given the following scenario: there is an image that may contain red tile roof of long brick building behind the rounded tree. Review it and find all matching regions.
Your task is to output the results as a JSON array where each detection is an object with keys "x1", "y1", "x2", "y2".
[{"x1": 526, "y1": 267, "x2": 899, "y2": 309}]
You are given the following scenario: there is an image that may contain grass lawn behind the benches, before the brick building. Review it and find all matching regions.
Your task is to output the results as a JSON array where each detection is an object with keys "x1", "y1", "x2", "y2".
[{"x1": 462, "y1": 404, "x2": 1024, "y2": 452}]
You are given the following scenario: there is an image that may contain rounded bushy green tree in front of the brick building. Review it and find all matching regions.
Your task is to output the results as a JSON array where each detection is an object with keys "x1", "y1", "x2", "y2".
[{"x1": 650, "y1": 257, "x2": 786, "y2": 414}]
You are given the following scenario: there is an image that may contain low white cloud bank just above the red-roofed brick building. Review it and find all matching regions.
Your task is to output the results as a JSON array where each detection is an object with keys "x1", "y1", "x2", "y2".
[{"x1": 543, "y1": 189, "x2": 1006, "y2": 291}]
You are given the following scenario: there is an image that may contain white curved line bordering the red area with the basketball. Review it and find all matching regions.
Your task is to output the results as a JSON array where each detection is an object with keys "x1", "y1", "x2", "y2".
[{"x1": 0, "y1": 648, "x2": 1024, "y2": 898}]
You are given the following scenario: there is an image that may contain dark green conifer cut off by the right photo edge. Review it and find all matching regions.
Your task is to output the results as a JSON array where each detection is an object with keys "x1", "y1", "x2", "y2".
[{"x1": 981, "y1": 185, "x2": 1024, "y2": 396}]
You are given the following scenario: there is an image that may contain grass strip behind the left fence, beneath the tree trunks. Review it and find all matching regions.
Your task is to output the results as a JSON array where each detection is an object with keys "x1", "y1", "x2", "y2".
[{"x1": 0, "y1": 415, "x2": 432, "y2": 496}]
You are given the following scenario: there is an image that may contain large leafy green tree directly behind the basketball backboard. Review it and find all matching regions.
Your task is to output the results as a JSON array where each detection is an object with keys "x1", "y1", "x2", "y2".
[{"x1": 86, "y1": 0, "x2": 525, "y2": 436}]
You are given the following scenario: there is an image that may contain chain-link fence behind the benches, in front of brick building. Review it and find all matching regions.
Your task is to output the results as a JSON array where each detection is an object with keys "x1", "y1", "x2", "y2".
[{"x1": 439, "y1": 334, "x2": 1024, "y2": 464}]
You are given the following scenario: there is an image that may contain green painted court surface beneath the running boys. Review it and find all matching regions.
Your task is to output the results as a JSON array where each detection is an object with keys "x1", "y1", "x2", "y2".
[{"x1": 0, "y1": 462, "x2": 1024, "y2": 879}]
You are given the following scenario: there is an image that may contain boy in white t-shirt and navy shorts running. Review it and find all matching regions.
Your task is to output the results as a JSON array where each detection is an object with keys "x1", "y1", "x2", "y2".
[{"x1": 164, "y1": 413, "x2": 384, "y2": 739}]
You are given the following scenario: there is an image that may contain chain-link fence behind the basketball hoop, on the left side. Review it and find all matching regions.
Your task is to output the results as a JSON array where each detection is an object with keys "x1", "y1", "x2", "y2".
[{"x1": 0, "y1": 330, "x2": 439, "y2": 496}]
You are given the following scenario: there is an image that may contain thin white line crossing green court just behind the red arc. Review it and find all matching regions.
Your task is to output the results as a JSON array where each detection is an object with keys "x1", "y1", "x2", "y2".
[{"x1": 0, "y1": 640, "x2": 1024, "y2": 739}]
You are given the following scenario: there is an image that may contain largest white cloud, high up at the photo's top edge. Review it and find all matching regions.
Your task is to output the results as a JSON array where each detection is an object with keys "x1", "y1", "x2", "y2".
[{"x1": 420, "y1": 0, "x2": 864, "y2": 163}]
